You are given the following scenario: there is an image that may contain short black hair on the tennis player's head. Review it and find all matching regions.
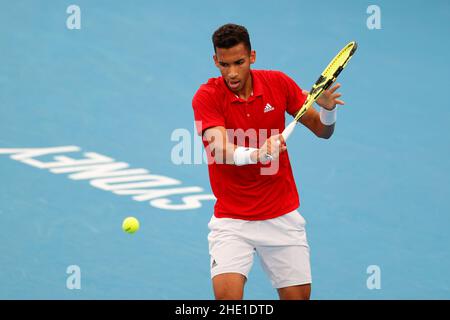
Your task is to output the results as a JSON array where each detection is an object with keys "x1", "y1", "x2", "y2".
[{"x1": 212, "y1": 23, "x2": 252, "y2": 52}]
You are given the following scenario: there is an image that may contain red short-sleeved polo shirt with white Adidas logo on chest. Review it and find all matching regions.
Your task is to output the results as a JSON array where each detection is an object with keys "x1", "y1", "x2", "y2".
[{"x1": 192, "y1": 70, "x2": 306, "y2": 220}]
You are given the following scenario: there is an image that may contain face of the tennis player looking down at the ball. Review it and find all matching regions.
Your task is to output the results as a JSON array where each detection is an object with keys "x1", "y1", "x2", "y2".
[{"x1": 214, "y1": 43, "x2": 256, "y2": 93}]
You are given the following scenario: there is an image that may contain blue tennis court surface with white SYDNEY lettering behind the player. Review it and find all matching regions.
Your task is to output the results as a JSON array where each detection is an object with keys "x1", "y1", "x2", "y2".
[{"x1": 0, "y1": 0, "x2": 450, "y2": 299}]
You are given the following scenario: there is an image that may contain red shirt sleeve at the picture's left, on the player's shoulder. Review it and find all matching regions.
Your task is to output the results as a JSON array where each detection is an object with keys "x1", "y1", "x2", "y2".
[{"x1": 192, "y1": 88, "x2": 225, "y2": 136}]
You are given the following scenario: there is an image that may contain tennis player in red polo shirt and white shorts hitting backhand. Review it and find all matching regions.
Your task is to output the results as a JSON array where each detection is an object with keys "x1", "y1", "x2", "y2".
[{"x1": 192, "y1": 24, "x2": 344, "y2": 300}]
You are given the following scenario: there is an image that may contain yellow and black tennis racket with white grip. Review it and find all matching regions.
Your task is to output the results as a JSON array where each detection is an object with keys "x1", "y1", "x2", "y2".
[{"x1": 282, "y1": 41, "x2": 358, "y2": 141}]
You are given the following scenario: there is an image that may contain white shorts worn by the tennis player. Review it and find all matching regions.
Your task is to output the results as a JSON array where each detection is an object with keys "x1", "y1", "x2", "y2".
[{"x1": 208, "y1": 210, "x2": 311, "y2": 289}]
